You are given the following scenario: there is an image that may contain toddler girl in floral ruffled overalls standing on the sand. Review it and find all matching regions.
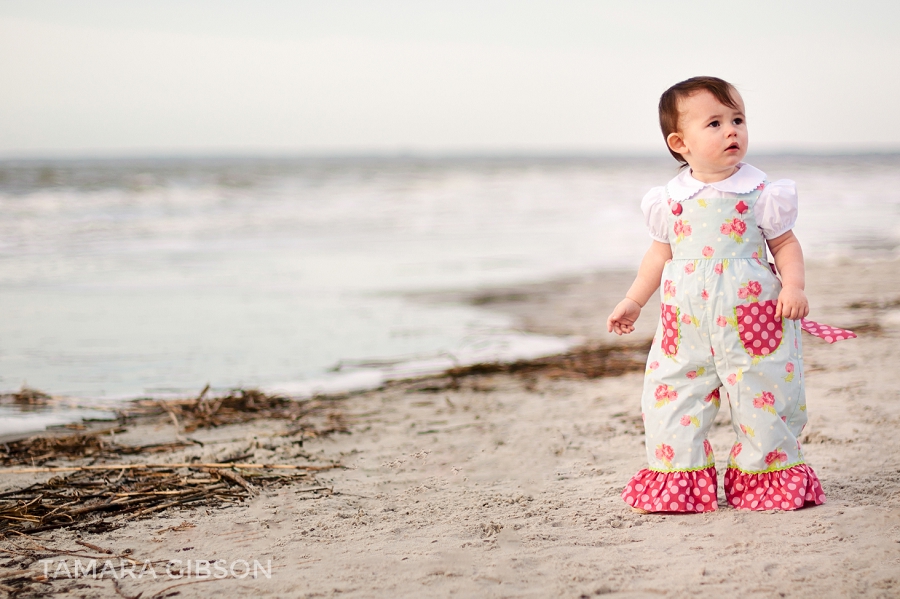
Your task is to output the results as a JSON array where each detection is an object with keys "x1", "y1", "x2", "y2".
[{"x1": 607, "y1": 77, "x2": 855, "y2": 513}]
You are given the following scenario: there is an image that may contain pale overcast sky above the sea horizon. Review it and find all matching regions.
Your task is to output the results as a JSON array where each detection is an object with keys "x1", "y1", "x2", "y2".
[{"x1": 0, "y1": 0, "x2": 900, "y2": 157}]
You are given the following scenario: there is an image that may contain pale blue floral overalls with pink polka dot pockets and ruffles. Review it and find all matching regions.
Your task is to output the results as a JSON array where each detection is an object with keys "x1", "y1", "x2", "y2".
[{"x1": 622, "y1": 167, "x2": 854, "y2": 512}]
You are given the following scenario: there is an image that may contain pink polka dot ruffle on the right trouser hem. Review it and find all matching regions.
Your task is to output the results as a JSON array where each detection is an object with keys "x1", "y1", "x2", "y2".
[{"x1": 725, "y1": 464, "x2": 825, "y2": 510}]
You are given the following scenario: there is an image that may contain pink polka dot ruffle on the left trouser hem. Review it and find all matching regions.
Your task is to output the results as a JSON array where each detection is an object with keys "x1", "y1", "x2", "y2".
[{"x1": 622, "y1": 467, "x2": 716, "y2": 512}]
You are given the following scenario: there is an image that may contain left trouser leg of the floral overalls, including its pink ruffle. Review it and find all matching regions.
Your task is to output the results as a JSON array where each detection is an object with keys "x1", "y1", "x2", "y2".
[{"x1": 622, "y1": 343, "x2": 721, "y2": 512}]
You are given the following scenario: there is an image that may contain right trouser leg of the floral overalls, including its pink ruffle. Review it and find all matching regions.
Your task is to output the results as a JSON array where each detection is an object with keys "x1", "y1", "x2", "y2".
[{"x1": 722, "y1": 320, "x2": 825, "y2": 510}]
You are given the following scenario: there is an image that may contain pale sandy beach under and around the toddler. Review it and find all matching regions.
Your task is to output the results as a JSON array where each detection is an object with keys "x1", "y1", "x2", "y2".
[{"x1": 0, "y1": 261, "x2": 900, "y2": 598}]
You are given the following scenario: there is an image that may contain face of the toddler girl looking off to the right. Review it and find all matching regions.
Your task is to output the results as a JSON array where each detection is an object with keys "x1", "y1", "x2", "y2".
[{"x1": 667, "y1": 90, "x2": 748, "y2": 180}]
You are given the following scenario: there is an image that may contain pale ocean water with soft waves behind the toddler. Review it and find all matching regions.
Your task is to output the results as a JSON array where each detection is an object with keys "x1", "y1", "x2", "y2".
[{"x1": 0, "y1": 155, "x2": 900, "y2": 433}]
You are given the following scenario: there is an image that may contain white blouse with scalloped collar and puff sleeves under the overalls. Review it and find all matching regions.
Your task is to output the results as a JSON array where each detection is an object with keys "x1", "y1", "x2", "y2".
[{"x1": 641, "y1": 162, "x2": 797, "y2": 243}]
